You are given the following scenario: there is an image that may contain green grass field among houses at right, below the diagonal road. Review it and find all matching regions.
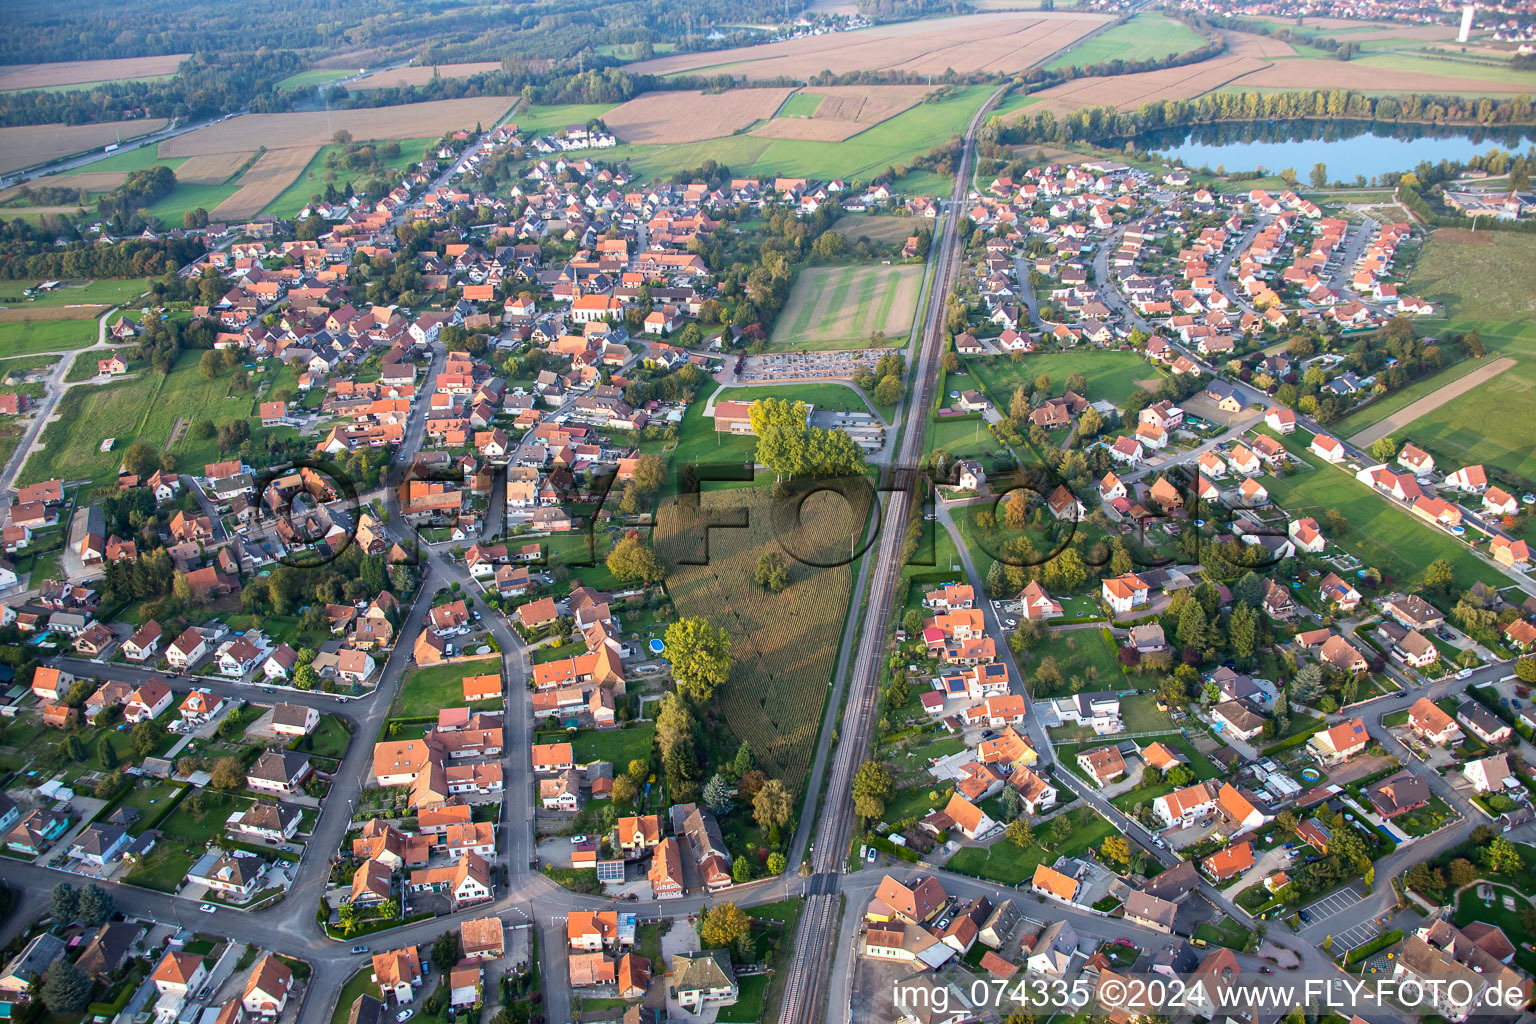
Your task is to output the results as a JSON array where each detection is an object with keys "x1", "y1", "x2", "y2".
[{"x1": 1261, "y1": 433, "x2": 1504, "y2": 591}]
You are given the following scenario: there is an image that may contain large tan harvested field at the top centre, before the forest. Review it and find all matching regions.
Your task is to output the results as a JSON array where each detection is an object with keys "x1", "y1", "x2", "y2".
[{"x1": 627, "y1": 12, "x2": 1111, "y2": 80}]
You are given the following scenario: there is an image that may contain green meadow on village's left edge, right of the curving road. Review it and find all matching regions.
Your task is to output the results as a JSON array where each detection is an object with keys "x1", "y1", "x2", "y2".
[{"x1": 18, "y1": 348, "x2": 284, "y2": 484}]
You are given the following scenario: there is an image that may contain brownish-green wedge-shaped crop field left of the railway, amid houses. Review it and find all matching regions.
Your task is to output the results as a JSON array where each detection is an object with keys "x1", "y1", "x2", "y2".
[{"x1": 654, "y1": 482, "x2": 865, "y2": 794}]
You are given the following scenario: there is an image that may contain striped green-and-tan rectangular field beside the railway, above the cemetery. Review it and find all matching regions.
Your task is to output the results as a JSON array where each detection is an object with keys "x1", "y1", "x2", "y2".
[{"x1": 771, "y1": 264, "x2": 923, "y2": 348}]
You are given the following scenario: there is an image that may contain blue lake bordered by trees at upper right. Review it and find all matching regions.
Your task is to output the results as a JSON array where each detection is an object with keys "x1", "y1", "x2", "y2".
[{"x1": 1135, "y1": 121, "x2": 1536, "y2": 183}]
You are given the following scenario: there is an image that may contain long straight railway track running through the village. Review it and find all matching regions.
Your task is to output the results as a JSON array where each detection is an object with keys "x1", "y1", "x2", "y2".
[{"x1": 779, "y1": 86, "x2": 1008, "y2": 1024}]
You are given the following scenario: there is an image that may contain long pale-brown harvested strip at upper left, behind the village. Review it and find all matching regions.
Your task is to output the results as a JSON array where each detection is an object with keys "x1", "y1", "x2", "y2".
[{"x1": 159, "y1": 97, "x2": 513, "y2": 160}]
